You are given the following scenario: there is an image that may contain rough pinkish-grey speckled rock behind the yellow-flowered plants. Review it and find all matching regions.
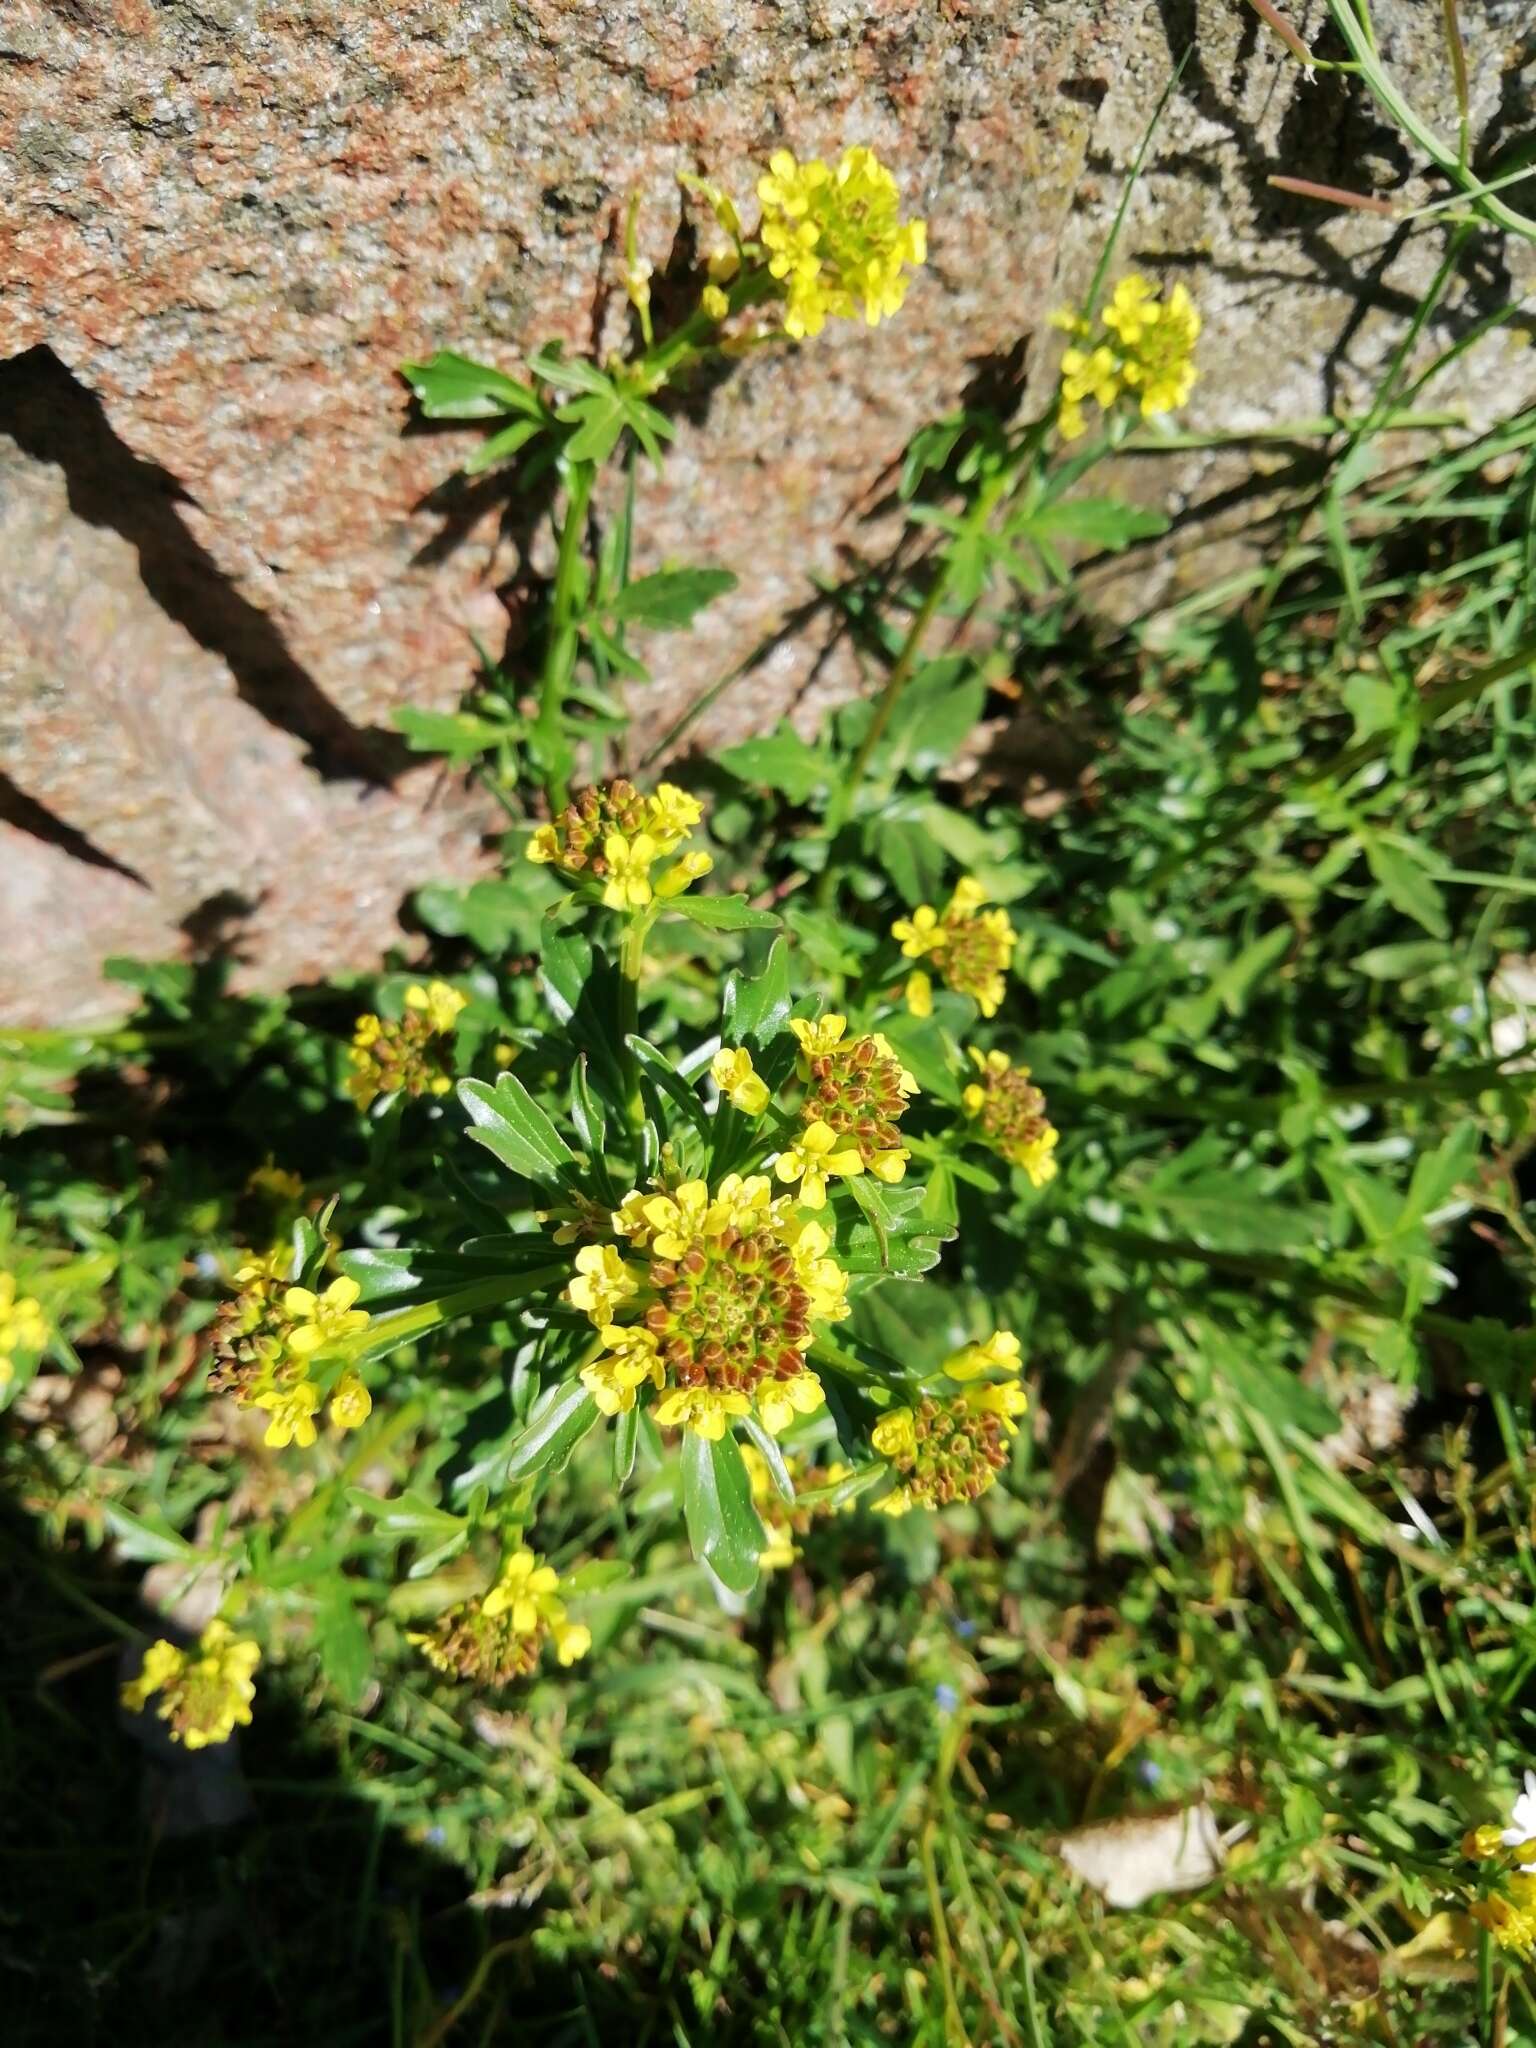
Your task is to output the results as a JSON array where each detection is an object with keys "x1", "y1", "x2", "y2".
[{"x1": 0, "y1": 0, "x2": 1536, "y2": 1016}]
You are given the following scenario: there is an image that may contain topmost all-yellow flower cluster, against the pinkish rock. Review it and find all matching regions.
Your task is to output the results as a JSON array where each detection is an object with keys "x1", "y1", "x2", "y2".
[{"x1": 757, "y1": 147, "x2": 928, "y2": 340}]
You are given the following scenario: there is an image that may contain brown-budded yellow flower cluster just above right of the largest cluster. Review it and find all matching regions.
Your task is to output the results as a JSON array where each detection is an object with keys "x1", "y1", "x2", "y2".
[{"x1": 774, "y1": 1014, "x2": 918, "y2": 1208}]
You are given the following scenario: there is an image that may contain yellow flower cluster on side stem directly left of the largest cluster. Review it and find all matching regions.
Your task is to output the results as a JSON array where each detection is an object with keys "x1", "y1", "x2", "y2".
[{"x1": 209, "y1": 1245, "x2": 373, "y2": 1450}]
